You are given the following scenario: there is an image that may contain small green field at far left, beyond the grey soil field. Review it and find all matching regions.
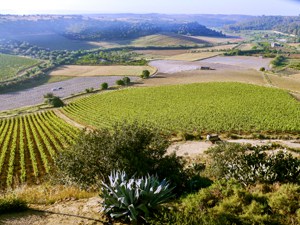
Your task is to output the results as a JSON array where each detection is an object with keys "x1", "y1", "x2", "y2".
[{"x1": 0, "y1": 54, "x2": 39, "y2": 82}]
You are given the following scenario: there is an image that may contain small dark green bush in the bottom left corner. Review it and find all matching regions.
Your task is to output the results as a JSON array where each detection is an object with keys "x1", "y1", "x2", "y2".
[{"x1": 0, "y1": 196, "x2": 28, "y2": 215}]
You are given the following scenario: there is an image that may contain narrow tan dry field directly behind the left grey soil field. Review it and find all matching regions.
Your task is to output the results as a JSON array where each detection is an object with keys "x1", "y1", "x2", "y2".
[{"x1": 50, "y1": 65, "x2": 156, "y2": 77}]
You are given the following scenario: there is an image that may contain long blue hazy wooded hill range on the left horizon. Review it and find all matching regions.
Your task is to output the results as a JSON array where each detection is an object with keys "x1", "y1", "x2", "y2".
[{"x1": 0, "y1": 14, "x2": 224, "y2": 44}]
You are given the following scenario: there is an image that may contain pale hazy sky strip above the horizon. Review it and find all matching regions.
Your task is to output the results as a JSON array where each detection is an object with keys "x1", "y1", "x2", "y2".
[{"x1": 0, "y1": 0, "x2": 300, "y2": 15}]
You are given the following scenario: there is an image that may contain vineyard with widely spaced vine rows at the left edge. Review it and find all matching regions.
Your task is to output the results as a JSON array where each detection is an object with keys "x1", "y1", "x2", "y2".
[{"x1": 0, "y1": 111, "x2": 78, "y2": 188}]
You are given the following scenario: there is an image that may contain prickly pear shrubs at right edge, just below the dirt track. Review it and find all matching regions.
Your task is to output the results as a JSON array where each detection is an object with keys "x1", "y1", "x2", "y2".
[{"x1": 208, "y1": 144, "x2": 300, "y2": 185}]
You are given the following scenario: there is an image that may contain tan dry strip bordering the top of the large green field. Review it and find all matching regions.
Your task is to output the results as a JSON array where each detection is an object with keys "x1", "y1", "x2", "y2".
[{"x1": 142, "y1": 70, "x2": 267, "y2": 86}]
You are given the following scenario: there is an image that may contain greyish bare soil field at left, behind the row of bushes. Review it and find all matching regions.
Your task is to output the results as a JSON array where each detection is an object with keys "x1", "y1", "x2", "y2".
[{"x1": 0, "y1": 76, "x2": 137, "y2": 111}]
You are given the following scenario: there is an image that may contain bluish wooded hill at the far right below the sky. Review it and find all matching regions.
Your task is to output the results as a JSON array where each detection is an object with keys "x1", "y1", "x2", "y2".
[{"x1": 225, "y1": 16, "x2": 300, "y2": 36}]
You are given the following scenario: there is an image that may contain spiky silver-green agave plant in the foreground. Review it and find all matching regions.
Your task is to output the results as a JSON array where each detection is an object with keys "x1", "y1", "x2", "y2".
[{"x1": 100, "y1": 171, "x2": 173, "y2": 224}]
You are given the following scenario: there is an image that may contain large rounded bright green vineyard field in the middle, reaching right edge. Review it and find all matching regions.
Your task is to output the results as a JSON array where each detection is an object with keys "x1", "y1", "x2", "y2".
[{"x1": 63, "y1": 83, "x2": 300, "y2": 134}]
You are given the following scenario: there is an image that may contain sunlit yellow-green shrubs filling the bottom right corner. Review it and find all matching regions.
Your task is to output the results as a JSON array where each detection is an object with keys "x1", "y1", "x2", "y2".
[{"x1": 150, "y1": 180, "x2": 300, "y2": 225}]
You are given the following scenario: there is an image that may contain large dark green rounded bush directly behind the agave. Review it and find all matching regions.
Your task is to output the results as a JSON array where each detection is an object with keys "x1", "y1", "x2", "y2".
[{"x1": 55, "y1": 123, "x2": 186, "y2": 190}]
